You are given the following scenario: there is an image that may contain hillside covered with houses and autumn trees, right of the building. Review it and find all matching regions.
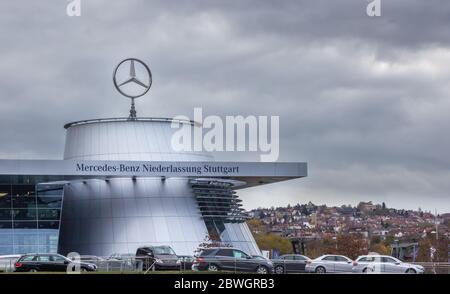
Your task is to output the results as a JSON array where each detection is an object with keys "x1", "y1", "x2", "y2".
[{"x1": 247, "y1": 201, "x2": 450, "y2": 261}]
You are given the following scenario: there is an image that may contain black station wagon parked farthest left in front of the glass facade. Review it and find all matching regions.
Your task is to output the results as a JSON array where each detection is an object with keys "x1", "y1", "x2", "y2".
[{"x1": 14, "y1": 253, "x2": 97, "y2": 272}]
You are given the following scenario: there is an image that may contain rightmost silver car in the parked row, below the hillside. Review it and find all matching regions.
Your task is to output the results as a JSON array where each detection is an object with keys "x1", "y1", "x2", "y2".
[{"x1": 353, "y1": 255, "x2": 425, "y2": 274}]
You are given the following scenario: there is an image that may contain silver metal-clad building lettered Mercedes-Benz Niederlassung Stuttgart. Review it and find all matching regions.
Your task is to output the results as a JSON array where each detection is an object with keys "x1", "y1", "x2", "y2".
[{"x1": 0, "y1": 58, "x2": 307, "y2": 256}]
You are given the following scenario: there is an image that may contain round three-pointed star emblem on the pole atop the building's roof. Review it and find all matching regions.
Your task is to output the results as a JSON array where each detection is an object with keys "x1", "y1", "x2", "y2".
[{"x1": 113, "y1": 58, "x2": 152, "y2": 99}]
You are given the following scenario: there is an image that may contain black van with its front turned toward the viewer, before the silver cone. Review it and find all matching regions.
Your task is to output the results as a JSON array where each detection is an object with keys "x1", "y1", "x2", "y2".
[{"x1": 136, "y1": 246, "x2": 181, "y2": 271}]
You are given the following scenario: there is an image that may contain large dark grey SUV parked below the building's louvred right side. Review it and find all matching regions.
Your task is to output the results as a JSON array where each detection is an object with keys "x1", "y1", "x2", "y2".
[{"x1": 192, "y1": 247, "x2": 273, "y2": 274}]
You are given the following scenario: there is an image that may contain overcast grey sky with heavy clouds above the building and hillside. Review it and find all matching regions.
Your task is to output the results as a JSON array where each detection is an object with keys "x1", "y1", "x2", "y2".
[{"x1": 0, "y1": 0, "x2": 450, "y2": 212}]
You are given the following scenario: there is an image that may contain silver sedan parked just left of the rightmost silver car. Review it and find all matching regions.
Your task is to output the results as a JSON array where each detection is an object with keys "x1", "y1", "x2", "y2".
[{"x1": 305, "y1": 254, "x2": 353, "y2": 274}]
